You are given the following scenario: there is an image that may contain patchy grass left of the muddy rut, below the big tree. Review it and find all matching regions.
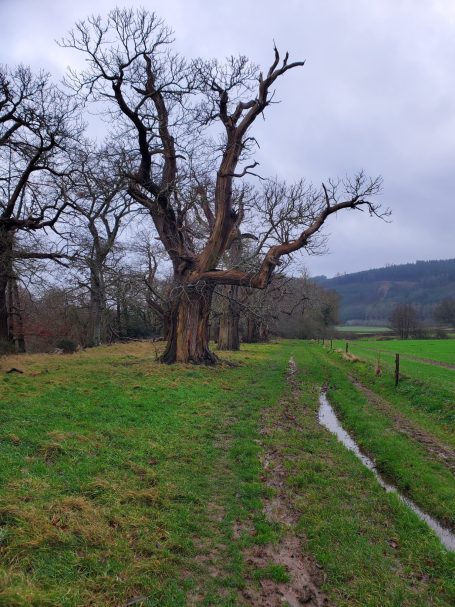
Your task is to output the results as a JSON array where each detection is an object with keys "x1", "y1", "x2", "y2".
[{"x1": 0, "y1": 345, "x2": 286, "y2": 607}]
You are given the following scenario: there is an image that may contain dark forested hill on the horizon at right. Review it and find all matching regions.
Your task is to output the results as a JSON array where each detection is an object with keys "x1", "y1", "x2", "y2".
[{"x1": 313, "y1": 259, "x2": 455, "y2": 322}]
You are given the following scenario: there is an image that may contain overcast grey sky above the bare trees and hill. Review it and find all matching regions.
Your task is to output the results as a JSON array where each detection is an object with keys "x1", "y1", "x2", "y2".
[{"x1": 0, "y1": 0, "x2": 455, "y2": 276}]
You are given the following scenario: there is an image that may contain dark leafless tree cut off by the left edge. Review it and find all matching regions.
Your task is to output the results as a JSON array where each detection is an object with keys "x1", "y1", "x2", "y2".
[{"x1": 0, "y1": 66, "x2": 81, "y2": 341}]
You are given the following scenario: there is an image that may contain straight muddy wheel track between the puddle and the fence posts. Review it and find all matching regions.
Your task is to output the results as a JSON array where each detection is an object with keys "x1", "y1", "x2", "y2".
[{"x1": 349, "y1": 375, "x2": 455, "y2": 473}]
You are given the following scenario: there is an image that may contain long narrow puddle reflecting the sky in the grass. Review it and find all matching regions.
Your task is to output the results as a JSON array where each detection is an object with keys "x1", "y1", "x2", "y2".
[{"x1": 318, "y1": 392, "x2": 455, "y2": 551}]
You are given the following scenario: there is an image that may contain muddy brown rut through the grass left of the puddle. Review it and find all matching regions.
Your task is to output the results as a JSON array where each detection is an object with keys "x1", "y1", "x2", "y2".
[{"x1": 242, "y1": 359, "x2": 329, "y2": 607}]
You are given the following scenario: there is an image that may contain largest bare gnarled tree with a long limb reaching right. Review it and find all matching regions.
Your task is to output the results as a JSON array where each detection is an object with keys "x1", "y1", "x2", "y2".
[{"x1": 62, "y1": 9, "x2": 386, "y2": 363}]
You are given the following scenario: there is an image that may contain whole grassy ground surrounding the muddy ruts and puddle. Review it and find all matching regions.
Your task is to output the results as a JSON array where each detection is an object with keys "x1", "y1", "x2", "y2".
[{"x1": 0, "y1": 341, "x2": 455, "y2": 607}]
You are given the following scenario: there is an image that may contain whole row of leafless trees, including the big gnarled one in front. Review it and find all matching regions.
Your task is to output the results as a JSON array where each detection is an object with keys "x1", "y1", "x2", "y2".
[{"x1": 0, "y1": 9, "x2": 383, "y2": 363}]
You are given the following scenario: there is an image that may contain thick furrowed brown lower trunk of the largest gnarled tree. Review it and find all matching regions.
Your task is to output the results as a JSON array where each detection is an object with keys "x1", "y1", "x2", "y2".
[{"x1": 161, "y1": 285, "x2": 217, "y2": 365}]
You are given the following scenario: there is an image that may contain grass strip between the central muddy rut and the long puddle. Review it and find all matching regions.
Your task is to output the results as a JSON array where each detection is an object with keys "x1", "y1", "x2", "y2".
[{"x1": 269, "y1": 343, "x2": 455, "y2": 607}]
